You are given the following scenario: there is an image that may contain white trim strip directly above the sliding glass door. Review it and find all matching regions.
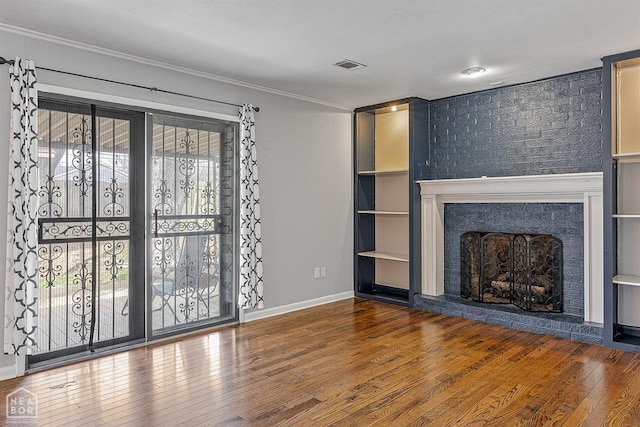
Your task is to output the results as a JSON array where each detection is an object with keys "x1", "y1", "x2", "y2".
[{"x1": 38, "y1": 83, "x2": 240, "y2": 123}]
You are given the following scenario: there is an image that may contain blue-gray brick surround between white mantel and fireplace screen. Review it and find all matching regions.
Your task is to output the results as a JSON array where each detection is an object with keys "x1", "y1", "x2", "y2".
[{"x1": 444, "y1": 203, "x2": 584, "y2": 316}]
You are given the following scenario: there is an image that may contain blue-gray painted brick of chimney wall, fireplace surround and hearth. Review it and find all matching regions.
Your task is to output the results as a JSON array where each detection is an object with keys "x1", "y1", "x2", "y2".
[{"x1": 416, "y1": 70, "x2": 603, "y2": 343}]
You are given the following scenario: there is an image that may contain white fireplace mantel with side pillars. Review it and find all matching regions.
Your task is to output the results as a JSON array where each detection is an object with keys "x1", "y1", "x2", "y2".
[{"x1": 418, "y1": 172, "x2": 604, "y2": 323}]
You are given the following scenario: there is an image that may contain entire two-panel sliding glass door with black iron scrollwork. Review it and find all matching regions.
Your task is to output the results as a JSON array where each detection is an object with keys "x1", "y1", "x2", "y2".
[{"x1": 28, "y1": 98, "x2": 238, "y2": 365}]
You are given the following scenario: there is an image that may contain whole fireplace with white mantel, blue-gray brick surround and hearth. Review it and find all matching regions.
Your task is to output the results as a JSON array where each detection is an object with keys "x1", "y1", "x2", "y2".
[{"x1": 416, "y1": 172, "x2": 604, "y2": 342}]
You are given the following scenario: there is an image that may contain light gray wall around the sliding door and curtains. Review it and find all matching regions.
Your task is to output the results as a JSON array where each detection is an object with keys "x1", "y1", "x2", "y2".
[{"x1": 0, "y1": 31, "x2": 353, "y2": 369}]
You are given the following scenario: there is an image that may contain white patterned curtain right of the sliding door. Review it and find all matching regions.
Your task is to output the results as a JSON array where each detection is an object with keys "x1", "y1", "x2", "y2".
[{"x1": 238, "y1": 104, "x2": 264, "y2": 308}]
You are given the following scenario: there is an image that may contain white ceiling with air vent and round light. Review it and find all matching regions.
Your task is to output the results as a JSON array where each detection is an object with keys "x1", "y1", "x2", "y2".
[{"x1": 0, "y1": 0, "x2": 640, "y2": 109}]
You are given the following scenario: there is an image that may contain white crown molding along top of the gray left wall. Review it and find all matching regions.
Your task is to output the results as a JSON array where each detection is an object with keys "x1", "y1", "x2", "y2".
[{"x1": 0, "y1": 23, "x2": 352, "y2": 111}]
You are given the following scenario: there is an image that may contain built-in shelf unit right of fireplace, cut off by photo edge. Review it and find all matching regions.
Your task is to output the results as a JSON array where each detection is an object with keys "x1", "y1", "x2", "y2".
[{"x1": 603, "y1": 50, "x2": 640, "y2": 351}]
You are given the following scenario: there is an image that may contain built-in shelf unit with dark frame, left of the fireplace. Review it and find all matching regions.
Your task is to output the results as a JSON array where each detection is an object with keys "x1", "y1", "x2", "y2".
[{"x1": 354, "y1": 98, "x2": 429, "y2": 305}]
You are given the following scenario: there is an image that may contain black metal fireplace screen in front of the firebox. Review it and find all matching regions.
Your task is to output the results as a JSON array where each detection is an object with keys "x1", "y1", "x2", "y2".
[{"x1": 460, "y1": 231, "x2": 562, "y2": 313}]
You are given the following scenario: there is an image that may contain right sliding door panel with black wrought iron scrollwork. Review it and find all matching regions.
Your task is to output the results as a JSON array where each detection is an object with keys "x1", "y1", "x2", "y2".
[{"x1": 148, "y1": 114, "x2": 238, "y2": 336}]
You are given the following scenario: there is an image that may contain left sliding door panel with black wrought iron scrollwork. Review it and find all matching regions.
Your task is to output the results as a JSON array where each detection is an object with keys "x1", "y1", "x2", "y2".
[{"x1": 29, "y1": 99, "x2": 144, "y2": 364}]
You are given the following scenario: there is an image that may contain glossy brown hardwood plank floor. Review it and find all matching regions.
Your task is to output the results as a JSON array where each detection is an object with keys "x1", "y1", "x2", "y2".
[{"x1": 0, "y1": 299, "x2": 640, "y2": 426}]
